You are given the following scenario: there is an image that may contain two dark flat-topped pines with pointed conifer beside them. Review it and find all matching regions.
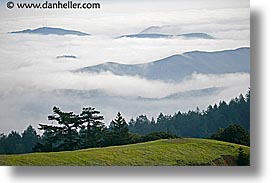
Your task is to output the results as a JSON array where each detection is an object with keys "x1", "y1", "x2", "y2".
[{"x1": 34, "y1": 107, "x2": 135, "y2": 152}]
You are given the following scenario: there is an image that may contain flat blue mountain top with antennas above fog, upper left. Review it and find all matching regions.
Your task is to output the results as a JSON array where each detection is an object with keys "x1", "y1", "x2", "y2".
[{"x1": 9, "y1": 27, "x2": 90, "y2": 36}]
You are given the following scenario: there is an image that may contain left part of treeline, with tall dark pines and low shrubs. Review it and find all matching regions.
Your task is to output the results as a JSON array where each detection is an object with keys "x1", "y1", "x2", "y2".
[{"x1": 0, "y1": 107, "x2": 178, "y2": 154}]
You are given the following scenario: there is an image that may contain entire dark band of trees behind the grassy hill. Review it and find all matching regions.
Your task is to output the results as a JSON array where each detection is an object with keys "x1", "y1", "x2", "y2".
[{"x1": 0, "y1": 91, "x2": 250, "y2": 154}]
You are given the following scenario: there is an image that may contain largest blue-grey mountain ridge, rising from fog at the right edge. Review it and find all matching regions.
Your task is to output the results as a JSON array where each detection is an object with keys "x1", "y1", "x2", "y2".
[{"x1": 74, "y1": 47, "x2": 250, "y2": 82}]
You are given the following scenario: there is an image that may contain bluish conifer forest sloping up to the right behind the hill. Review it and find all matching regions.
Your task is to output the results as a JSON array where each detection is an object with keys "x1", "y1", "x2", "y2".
[{"x1": 129, "y1": 91, "x2": 250, "y2": 138}]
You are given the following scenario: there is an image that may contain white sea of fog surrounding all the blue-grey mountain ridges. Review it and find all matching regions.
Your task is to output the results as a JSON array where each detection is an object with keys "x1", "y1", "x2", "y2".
[{"x1": 0, "y1": 0, "x2": 250, "y2": 133}]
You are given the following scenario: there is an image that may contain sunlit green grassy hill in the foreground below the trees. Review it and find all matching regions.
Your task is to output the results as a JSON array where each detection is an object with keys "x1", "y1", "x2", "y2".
[{"x1": 0, "y1": 138, "x2": 250, "y2": 166}]
